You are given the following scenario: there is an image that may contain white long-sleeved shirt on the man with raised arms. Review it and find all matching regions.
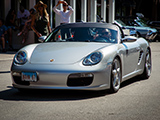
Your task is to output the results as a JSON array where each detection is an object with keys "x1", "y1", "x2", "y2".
[{"x1": 53, "y1": 6, "x2": 74, "y2": 23}]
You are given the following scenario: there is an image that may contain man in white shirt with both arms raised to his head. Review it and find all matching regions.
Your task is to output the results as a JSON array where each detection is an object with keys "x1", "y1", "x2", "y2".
[{"x1": 53, "y1": 1, "x2": 74, "y2": 24}]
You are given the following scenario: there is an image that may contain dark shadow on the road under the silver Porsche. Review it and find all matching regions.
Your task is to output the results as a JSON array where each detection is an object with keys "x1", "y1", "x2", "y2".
[{"x1": 0, "y1": 77, "x2": 148, "y2": 101}]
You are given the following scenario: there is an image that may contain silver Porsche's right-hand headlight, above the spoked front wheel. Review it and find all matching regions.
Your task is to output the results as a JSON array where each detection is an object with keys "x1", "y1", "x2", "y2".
[{"x1": 83, "y1": 52, "x2": 102, "y2": 66}]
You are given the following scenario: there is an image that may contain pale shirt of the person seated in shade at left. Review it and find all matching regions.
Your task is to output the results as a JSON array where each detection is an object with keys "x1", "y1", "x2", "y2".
[{"x1": 17, "y1": 9, "x2": 30, "y2": 25}]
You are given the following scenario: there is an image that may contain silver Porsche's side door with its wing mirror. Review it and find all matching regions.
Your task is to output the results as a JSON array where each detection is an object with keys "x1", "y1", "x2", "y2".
[{"x1": 118, "y1": 23, "x2": 140, "y2": 77}]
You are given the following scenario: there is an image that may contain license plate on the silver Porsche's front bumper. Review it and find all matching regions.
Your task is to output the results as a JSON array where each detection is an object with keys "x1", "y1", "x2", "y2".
[{"x1": 22, "y1": 72, "x2": 37, "y2": 82}]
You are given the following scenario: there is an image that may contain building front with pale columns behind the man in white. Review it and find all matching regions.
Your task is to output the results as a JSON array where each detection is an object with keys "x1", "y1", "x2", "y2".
[{"x1": 0, "y1": 0, "x2": 115, "y2": 28}]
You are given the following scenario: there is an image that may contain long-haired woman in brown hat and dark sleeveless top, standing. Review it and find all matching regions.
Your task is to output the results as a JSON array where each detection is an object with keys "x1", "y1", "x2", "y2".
[{"x1": 31, "y1": 1, "x2": 51, "y2": 43}]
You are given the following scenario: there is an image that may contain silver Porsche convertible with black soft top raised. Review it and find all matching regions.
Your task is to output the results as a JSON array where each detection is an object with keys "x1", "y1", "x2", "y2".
[{"x1": 11, "y1": 23, "x2": 152, "y2": 93}]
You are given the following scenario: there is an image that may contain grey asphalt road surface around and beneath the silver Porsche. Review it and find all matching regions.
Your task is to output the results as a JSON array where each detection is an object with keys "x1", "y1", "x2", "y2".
[{"x1": 0, "y1": 43, "x2": 160, "y2": 120}]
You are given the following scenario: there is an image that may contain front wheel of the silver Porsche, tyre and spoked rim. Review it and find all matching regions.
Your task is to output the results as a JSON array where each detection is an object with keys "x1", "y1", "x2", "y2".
[{"x1": 109, "y1": 58, "x2": 122, "y2": 93}]
